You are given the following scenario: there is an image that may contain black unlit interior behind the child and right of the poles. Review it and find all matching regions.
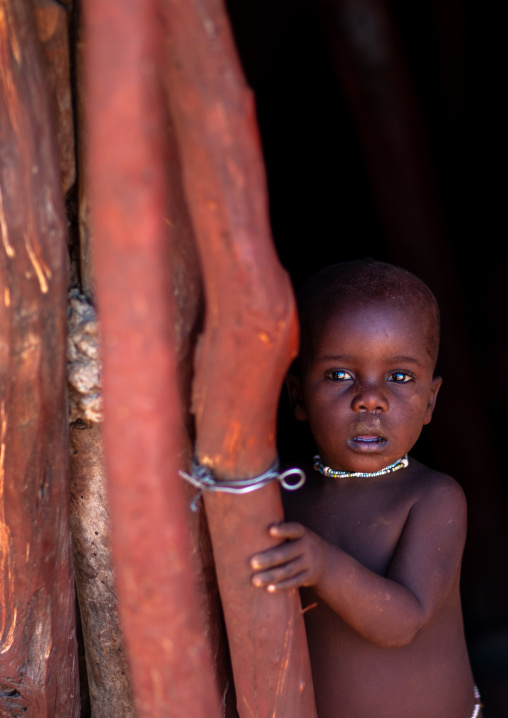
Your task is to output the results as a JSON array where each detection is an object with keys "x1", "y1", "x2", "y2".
[{"x1": 227, "y1": 0, "x2": 508, "y2": 718}]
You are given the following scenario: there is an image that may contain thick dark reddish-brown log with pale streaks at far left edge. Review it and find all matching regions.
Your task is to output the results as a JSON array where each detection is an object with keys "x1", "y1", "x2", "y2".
[{"x1": 0, "y1": 0, "x2": 80, "y2": 718}]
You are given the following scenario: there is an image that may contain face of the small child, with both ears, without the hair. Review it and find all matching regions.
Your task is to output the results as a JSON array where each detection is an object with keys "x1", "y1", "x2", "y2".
[{"x1": 288, "y1": 301, "x2": 441, "y2": 472}]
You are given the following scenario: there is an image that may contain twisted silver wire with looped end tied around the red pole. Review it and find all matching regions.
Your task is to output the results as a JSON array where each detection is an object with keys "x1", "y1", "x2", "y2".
[{"x1": 180, "y1": 458, "x2": 306, "y2": 511}]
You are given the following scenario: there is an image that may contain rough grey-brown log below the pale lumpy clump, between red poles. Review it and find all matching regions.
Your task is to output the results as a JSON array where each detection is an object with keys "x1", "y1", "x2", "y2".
[{"x1": 70, "y1": 422, "x2": 137, "y2": 718}]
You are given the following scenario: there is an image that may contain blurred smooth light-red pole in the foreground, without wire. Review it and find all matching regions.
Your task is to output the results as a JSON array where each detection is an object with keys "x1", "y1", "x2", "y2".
[{"x1": 84, "y1": 0, "x2": 219, "y2": 718}]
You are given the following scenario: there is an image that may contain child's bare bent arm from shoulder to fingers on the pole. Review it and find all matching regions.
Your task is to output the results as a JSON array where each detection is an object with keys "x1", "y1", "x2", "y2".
[{"x1": 251, "y1": 477, "x2": 466, "y2": 647}]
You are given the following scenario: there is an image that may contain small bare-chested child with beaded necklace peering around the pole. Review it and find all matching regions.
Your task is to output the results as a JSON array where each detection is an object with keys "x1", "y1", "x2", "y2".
[{"x1": 251, "y1": 260, "x2": 481, "y2": 718}]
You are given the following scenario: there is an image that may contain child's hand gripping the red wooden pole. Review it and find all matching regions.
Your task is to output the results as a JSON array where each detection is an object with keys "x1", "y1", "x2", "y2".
[{"x1": 250, "y1": 522, "x2": 327, "y2": 593}]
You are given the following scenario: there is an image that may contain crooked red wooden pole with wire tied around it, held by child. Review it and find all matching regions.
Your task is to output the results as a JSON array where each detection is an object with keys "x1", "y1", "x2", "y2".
[{"x1": 161, "y1": 0, "x2": 316, "y2": 718}]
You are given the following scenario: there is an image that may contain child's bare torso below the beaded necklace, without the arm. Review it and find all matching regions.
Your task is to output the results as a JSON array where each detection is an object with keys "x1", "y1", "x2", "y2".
[{"x1": 285, "y1": 460, "x2": 475, "y2": 718}]
